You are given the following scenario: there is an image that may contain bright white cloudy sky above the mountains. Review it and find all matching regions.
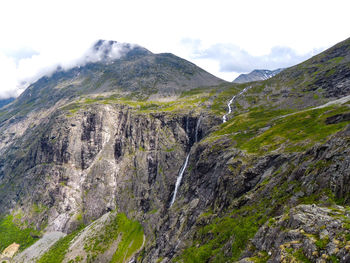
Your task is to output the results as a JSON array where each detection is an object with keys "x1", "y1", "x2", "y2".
[{"x1": 0, "y1": 0, "x2": 350, "y2": 99}]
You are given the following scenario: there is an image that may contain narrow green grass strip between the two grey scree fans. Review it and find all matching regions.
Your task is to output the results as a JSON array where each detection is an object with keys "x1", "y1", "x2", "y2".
[{"x1": 37, "y1": 225, "x2": 84, "y2": 263}]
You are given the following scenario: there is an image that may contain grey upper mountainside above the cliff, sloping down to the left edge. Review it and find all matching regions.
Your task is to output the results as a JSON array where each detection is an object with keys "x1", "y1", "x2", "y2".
[{"x1": 0, "y1": 41, "x2": 224, "y2": 157}]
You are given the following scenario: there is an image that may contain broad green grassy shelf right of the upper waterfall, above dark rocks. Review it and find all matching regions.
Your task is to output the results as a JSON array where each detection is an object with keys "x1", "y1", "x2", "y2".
[{"x1": 208, "y1": 106, "x2": 349, "y2": 153}]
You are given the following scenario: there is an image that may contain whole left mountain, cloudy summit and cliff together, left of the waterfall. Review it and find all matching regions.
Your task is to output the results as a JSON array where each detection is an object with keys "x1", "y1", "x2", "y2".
[{"x1": 0, "y1": 39, "x2": 224, "y2": 262}]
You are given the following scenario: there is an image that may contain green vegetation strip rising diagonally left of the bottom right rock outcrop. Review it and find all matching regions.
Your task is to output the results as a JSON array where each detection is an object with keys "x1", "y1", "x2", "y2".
[{"x1": 177, "y1": 182, "x2": 293, "y2": 263}]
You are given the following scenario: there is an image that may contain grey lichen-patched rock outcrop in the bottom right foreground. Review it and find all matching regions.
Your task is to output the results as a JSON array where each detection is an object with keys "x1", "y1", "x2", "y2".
[{"x1": 240, "y1": 205, "x2": 350, "y2": 262}]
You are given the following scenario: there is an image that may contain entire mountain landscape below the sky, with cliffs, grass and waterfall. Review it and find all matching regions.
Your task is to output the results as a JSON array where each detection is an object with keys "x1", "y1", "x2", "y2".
[{"x1": 0, "y1": 39, "x2": 350, "y2": 263}]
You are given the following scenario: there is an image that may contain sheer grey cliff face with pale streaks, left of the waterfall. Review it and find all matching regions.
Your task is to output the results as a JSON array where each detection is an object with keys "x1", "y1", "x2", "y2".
[{"x1": 0, "y1": 102, "x2": 220, "y2": 234}]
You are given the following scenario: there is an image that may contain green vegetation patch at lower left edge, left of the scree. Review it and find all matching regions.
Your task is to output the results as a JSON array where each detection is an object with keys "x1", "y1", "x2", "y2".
[{"x1": 0, "y1": 215, "x2": 40, "y2": 252}]
